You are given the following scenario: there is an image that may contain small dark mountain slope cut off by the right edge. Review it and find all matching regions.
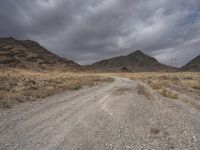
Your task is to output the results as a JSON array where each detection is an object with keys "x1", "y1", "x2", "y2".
[{"x1": 180, "y1": 55, "x2": 200, "y2": 71}]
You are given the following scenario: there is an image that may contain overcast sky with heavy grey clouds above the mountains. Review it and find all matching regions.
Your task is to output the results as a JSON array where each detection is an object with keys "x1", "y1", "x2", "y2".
[{"x1": 0, "y1": 0, "x2": 200, "y2": 66}]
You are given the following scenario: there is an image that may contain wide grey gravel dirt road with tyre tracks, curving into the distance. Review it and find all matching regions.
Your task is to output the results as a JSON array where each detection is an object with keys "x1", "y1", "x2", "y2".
[{"x1": 0, "y1": 78, "x2": 200, "y2": 150}]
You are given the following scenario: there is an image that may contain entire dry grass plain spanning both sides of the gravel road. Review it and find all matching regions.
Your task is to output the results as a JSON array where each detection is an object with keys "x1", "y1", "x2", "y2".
[{"x1": 0, "y1": 69, "x2": 200, "y2": 108}]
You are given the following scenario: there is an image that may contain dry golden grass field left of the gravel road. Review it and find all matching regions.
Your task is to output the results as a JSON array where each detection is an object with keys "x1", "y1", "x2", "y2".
[{"x1": 0, "y1": 69, "x2": 112, "y2": 108}]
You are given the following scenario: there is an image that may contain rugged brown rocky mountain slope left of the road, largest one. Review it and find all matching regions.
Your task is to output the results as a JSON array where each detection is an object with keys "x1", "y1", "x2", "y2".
[{"x1": 0, "y1": 38, "x2": 80, "y2": 70}]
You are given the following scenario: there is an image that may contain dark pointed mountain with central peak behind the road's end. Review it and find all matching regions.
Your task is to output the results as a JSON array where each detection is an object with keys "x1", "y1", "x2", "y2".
[{"x1": 89, "y1": 50, "x2": 176, "y2": 72}]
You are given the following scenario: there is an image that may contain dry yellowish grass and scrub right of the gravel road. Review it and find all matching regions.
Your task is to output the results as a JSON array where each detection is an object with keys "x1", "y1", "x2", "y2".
[{"x1": 109, "y1": 72, "x2": 200, "y2": 99}]
